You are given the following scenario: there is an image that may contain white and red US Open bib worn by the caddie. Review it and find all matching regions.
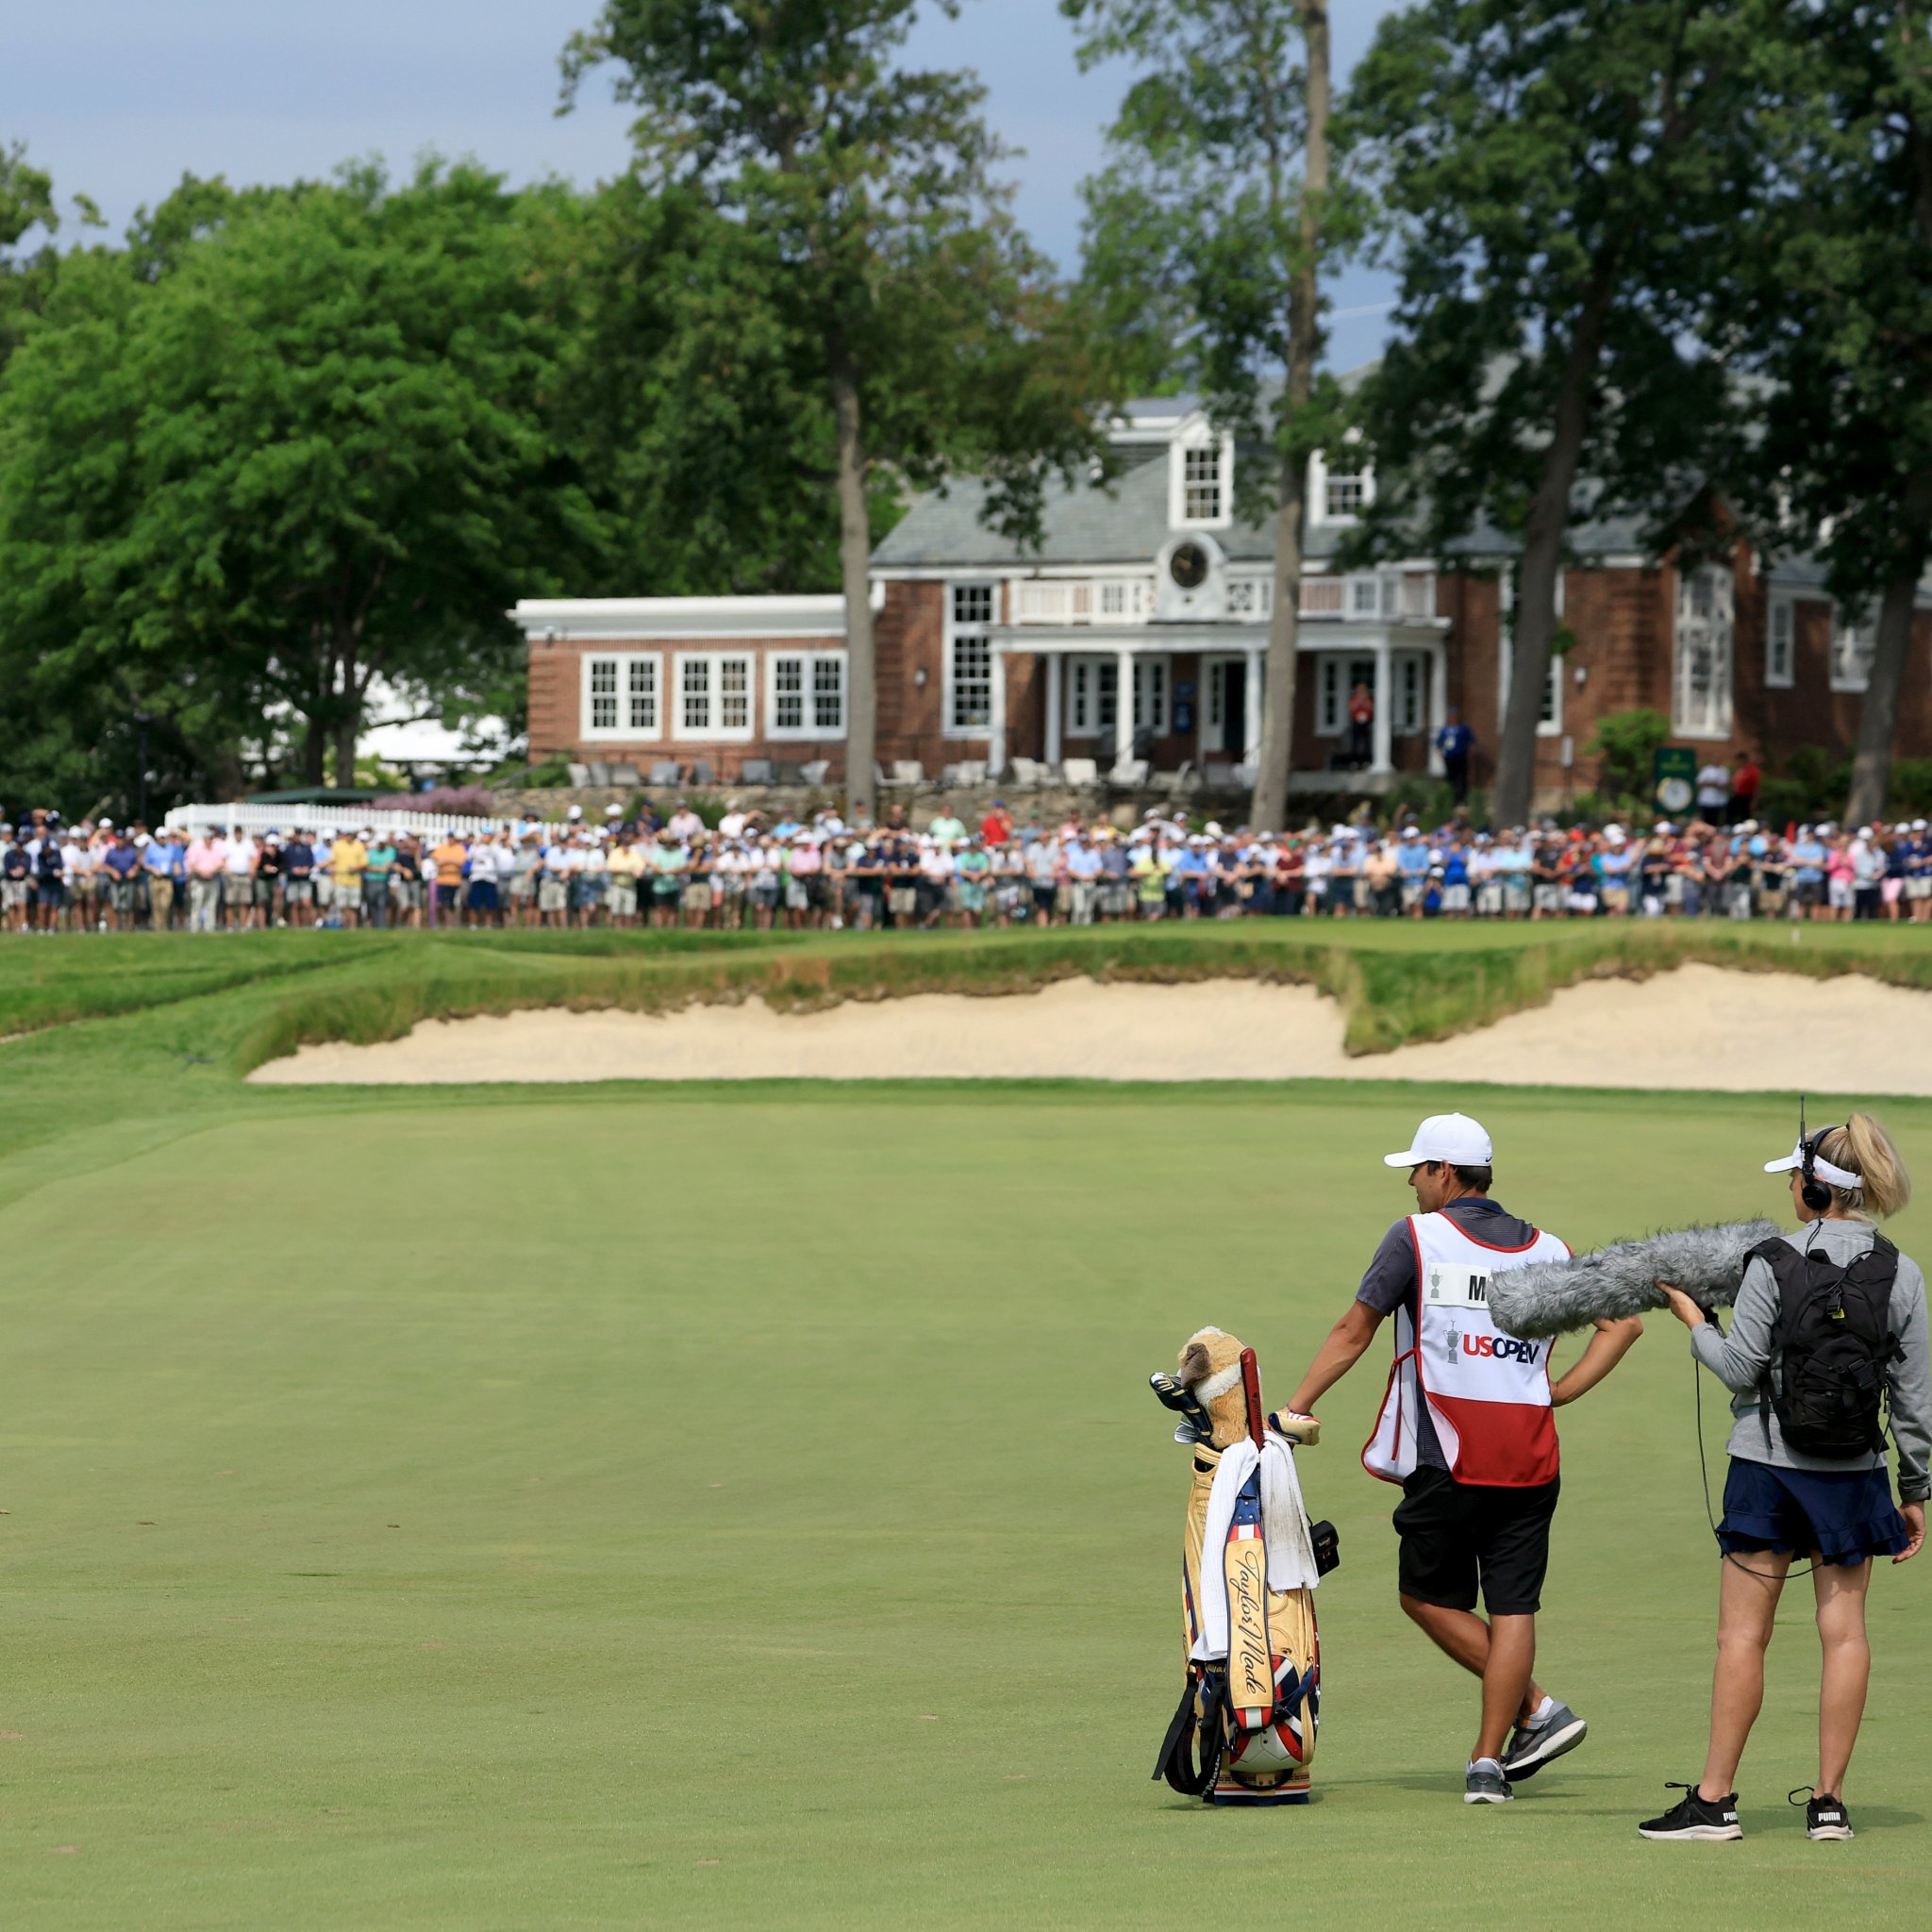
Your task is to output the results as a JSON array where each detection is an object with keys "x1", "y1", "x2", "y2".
[{"x1": 1362, "y1": 1213, "x2": 1571, "y2": 1490}]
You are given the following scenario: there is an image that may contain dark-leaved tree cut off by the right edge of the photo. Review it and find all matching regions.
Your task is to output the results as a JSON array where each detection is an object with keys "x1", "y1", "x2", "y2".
[{"x1": 1714, "y1": 0, "x2": 1932, "y2": 824}]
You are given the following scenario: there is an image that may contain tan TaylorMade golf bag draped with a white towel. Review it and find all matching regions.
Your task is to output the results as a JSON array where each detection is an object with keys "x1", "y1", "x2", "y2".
[{"x1": 1154, "y1": 1351, "x2": 1335, "y2": 1805}]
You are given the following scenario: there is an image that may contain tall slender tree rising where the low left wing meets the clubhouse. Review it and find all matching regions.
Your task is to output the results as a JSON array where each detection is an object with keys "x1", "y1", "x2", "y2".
[{"x1": 564, "y1": 0, "x2": 1095, "y2": 813}]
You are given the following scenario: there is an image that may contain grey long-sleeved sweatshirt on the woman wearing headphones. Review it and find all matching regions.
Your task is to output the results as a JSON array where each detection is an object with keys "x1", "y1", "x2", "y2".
[{"x1": 1690, "y1": 1221, "x2": 1932, "y2": 1503}]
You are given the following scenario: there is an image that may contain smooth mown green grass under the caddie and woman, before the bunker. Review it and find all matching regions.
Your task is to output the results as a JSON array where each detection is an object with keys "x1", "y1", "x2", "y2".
[{"x1": 0, "y1": 1081, "x2": 1932, "y2": 1932}]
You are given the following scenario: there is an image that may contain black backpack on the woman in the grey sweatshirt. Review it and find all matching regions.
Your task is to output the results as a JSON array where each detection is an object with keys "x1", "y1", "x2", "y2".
[{"x1": 1750, "y1": 1235, "x2": 1905, "y2": 1460}]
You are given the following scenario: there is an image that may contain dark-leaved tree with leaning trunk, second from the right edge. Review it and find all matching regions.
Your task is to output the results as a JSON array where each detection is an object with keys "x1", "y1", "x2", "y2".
[{"x1": 1351, "y1": 0, "x2": 1762, "y2": 824}]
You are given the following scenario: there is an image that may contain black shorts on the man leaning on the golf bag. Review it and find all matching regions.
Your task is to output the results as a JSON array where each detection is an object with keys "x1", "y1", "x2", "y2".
[{"x1": 1395, "y1": 1468, "x2": 1563, "y2": 1617}]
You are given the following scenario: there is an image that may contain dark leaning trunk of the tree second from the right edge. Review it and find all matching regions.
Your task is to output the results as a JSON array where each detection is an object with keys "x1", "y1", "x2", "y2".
[{"x1": 1490, "y1": 268, "x2": 1615, "y2": 824}]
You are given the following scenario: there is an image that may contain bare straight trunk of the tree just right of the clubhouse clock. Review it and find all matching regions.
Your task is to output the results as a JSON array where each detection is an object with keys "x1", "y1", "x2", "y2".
[{"x1": 1248, "y1": 0, "x2": 1329, "y2": 833}]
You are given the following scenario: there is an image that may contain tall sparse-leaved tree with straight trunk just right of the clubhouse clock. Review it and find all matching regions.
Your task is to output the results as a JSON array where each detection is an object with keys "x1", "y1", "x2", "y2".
[{"x1": 1060, "y1": 0, "x2": 1357, "y2": 827}]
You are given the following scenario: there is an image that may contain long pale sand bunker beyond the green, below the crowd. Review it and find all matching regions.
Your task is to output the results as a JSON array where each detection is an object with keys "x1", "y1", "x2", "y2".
[{"x1": 249, "y1": 966, "x2": 1932, "y2": 1093}]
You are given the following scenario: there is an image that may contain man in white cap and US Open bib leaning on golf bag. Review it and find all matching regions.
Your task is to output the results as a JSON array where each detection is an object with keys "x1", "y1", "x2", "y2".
[{"x1": 1291, "y1": 1113, "x2": 1642, "y2": 1805}]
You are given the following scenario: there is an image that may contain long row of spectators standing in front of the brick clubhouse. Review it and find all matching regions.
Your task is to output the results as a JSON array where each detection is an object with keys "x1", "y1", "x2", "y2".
[{"x1": 0, "y1": 800, "x2": 1932, "y2": 933}]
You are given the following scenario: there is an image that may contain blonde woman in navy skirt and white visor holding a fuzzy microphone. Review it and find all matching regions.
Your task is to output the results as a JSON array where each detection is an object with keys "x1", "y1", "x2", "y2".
[{"x1": 1639, "y1": 1113, "x2": 1932, "y2": 1840}]
